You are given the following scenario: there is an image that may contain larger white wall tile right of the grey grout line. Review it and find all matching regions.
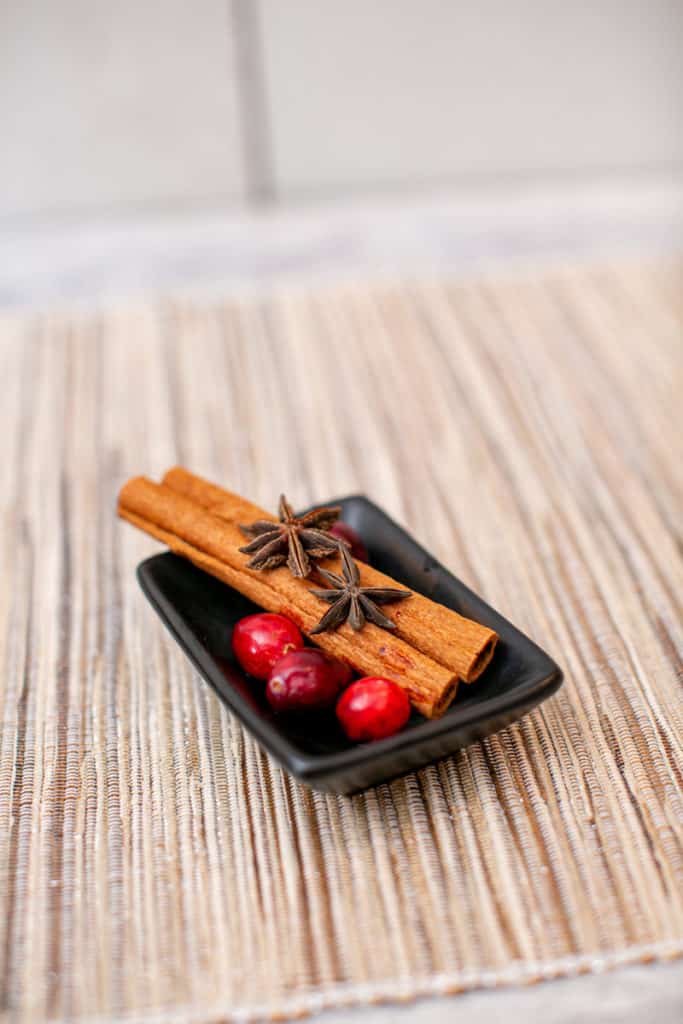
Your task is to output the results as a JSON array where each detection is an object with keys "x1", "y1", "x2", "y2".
[{"x1": 262, "y1": 0, "x2": 683, "y2": 196}]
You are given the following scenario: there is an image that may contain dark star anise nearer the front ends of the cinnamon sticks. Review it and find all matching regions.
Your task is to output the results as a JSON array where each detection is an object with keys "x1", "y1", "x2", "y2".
[{"x1": 310, "y1": 545, "x2": 411, "y2": 635}]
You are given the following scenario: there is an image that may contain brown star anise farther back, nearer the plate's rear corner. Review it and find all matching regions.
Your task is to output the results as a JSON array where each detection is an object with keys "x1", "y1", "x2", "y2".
[{"x1": 240, "y1": 495, "x2": 341, "y2": 577}]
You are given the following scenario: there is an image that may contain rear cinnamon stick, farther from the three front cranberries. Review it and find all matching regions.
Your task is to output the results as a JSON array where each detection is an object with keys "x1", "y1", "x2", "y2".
[{"x1": 164, "y1": 466, "x2": 498, "y2": 683}]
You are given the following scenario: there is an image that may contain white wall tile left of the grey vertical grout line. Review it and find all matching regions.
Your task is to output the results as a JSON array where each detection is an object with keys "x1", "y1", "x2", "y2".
[{"x1": 0, "y1": 0, "x2": 244, "y2": 215}]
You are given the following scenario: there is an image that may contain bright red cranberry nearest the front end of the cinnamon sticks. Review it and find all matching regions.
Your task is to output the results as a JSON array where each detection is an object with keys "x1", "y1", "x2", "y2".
[{"x1": 337, "y1": 676, "x2": 411, "y2": 740}]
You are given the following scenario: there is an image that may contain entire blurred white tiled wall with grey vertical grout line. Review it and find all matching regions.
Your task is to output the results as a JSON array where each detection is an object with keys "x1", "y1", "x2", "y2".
[{"x1": 0, "y1": 0, "x2": 683, "y2": 221}]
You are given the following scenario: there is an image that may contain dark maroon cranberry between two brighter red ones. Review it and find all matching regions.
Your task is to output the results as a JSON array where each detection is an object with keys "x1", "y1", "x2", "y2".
[{"x1": 265, "y1": 647, "x2": 341, "y2": 711}]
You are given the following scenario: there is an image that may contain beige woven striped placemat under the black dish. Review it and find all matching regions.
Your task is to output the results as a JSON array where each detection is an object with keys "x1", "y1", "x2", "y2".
[{"x1": 0, "y1": 258, "x2": 683, "y2": 1022}]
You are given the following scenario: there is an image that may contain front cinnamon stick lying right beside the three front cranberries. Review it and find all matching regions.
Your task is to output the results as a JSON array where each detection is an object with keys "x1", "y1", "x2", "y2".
[{"x1": 119, "y1": 477, "x2": 458, "y2": 718}]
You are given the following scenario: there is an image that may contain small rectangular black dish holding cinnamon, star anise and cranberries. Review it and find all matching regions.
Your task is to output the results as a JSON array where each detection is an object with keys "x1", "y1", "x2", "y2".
[{"x1": 137, "y1": 496, "x2": 562, "y2": 793}]
